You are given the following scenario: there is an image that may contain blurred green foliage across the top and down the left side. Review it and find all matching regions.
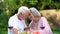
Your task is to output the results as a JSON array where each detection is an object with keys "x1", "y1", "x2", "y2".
[{"x1": 0, "y1": 0, "x2": 60, "y2": 34}]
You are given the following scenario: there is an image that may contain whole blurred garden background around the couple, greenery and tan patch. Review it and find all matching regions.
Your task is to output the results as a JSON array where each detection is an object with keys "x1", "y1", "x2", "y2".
[{"x1": 0, "y1": 0, "x2": 60, "y2": 34}]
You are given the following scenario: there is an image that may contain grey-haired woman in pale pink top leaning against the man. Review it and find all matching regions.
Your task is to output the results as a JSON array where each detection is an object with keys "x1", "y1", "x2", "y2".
[{"x1": 29, "y1": 8, "x2": 52, "y2": 34}]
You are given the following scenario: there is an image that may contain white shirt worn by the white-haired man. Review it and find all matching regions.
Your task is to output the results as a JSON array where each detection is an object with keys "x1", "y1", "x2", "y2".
[{"x1": 8, "y1": 14, "x2": 27, "y2": 34}]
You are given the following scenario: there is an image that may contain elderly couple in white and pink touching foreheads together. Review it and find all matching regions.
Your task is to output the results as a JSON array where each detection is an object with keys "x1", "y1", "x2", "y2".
[{"x1": 8, "y1": 6, "x2": 52, "y2": 34}]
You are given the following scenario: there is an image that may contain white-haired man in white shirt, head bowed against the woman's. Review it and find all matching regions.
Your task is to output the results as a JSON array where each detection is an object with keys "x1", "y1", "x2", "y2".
[{"x1": 8, "y1": 6, "x2": 29, "y2": 34}]
